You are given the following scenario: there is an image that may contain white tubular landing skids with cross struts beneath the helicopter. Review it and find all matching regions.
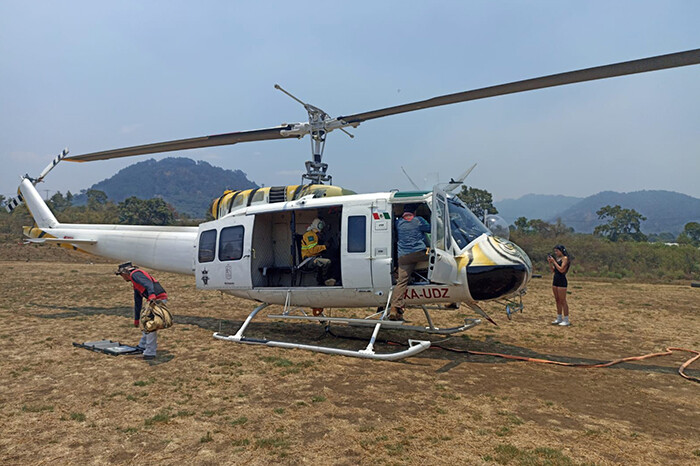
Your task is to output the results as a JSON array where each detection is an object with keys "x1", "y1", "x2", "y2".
[{"x1": 214, "y1": 303, "x2": 481, "y2": 361}]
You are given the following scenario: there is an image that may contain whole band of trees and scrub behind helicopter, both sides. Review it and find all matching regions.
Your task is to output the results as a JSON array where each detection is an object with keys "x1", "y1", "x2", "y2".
[{"x1": 0, "y1": 187, "x2": 700, "y2": 280}]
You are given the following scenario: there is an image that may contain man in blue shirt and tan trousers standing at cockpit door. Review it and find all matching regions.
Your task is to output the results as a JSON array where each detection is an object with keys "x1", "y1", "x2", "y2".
[{"x1": 389, "y1": 204, "x2": 430, "y2": 320}]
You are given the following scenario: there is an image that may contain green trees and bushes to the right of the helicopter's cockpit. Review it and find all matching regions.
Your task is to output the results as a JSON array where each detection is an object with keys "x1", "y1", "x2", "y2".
[{"x1": 459, "y1": 187, "x2": 700, "y2": 281}]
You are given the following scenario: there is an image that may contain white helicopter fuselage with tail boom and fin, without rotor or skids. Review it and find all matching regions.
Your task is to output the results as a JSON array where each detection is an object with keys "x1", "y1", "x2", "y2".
[{"x1": 20, "y1": 180, "x2": 532, "y2": 308}]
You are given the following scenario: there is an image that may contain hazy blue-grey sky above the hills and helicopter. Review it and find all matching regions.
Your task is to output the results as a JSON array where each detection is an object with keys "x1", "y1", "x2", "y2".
[{"x1": 0, "y1": 0, "x2": 700, "y2": 199}]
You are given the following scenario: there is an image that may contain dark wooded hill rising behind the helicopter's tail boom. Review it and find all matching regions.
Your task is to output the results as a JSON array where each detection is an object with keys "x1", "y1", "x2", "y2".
[{"x1": 74, "y1": 157, "x2": 258, "y2": 218}]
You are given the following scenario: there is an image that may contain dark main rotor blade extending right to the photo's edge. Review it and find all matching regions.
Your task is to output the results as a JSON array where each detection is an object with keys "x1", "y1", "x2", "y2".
[{"x1": 337, "y1": 49, "x2": 700, "y2": 125}]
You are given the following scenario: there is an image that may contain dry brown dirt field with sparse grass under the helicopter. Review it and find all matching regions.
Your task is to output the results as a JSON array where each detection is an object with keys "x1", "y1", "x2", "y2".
[{"x1": 0, "y1": 261, "x2": 700, "y2": 465}]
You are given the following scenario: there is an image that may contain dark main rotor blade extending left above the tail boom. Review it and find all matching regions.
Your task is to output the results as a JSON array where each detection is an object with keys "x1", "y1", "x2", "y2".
[{"x1": 63, "y1": 125, "x2": 297, "y2": 162}]
